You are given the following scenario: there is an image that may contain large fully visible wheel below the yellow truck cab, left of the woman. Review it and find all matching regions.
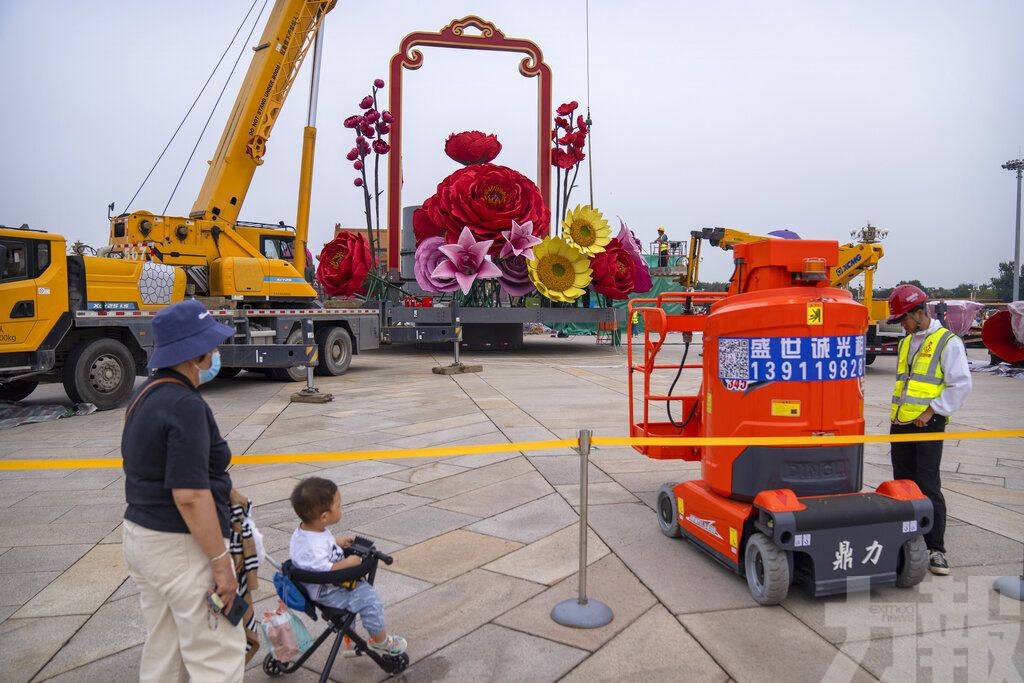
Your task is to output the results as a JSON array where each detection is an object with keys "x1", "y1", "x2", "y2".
[{"x1": 62, "y1": 338, "x2": 135, "y2": 411}]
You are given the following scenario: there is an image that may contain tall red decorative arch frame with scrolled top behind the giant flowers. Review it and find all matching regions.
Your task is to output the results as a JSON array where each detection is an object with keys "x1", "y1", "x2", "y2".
[{"x1": 387, "y1": 15, "x2": 551, "y2": 268}]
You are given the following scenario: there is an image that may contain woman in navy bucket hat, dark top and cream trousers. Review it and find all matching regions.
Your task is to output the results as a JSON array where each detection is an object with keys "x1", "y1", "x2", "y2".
[{"x1": 121, "y1": 300, "x2": 246, "y2": 681}]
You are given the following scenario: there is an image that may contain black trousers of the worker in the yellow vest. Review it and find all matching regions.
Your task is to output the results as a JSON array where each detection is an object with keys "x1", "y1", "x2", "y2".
[{"x1": 889, "y1": 415, "x2": 946, "y2": 553}]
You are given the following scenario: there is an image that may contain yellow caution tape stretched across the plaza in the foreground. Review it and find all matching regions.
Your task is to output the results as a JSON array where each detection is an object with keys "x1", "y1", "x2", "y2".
[{"x1": 0, "y1": 429, "x2": 1024, "y2": 471}]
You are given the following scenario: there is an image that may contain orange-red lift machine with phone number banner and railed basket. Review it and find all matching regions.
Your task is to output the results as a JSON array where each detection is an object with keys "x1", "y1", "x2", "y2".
[{"x1": 628, "y1": 240, "x2": 933, "y2": 605}]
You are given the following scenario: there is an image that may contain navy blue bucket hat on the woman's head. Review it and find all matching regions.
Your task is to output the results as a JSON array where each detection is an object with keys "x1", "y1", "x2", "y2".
[{"x1": 146, "y1": 299, "x2": 234, "y2": 370}]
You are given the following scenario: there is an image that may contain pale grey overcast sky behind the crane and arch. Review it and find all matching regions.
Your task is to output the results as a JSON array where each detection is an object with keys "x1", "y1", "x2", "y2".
[{"x1": 0, "y1": 0, "x2": 1024, "y2": 286}]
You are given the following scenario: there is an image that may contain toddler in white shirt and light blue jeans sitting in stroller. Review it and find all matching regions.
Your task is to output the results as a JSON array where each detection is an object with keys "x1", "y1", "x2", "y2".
[{"x1": 289, "y1": 477, "x2": 407, "y2": 655}]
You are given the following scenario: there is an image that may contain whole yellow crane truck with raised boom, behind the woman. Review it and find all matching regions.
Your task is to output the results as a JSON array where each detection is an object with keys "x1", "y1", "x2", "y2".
[{"x1": 0, "y1": 0, "x2": 380, "y2": 410}]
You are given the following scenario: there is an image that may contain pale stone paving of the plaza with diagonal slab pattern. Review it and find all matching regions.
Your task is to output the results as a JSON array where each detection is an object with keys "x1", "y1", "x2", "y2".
[{"x1": 0, "y1": 336, "x2": 1024, "y2": 682}]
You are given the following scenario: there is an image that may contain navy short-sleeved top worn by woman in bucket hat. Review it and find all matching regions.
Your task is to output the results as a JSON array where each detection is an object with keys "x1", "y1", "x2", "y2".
[{"x1": 121, "y1": 369, "x2": 231, "y2": 538}]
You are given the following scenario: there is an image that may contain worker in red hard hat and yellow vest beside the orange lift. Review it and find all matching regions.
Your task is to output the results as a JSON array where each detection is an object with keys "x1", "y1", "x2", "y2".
[{"x1": 889, "y1": 285, "x2": 971, "y2": 575}]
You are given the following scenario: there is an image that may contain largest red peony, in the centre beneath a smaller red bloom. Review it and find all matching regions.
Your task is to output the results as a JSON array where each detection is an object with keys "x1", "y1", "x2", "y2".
[{"x1": 413, "y1": 164, "x2": 551, "y2": 256}]
